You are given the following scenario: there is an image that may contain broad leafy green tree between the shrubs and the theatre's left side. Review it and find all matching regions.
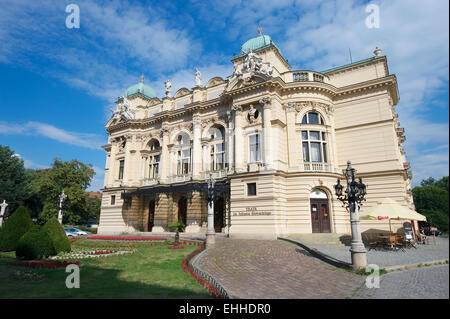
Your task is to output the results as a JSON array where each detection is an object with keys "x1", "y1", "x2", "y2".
[{"x1": 30, "y1": 159, "x2": 95, "y2": 224}]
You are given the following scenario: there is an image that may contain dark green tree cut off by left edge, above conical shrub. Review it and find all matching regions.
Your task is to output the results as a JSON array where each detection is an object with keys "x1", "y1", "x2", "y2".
[{"x1": 0, "y1": 145, "x2": 29, "y2": 211}]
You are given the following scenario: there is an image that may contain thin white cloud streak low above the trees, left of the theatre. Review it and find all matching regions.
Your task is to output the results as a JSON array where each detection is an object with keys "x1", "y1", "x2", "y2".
[{"x1": 0, "y1": 121, "x2": 104, "y2": 150}]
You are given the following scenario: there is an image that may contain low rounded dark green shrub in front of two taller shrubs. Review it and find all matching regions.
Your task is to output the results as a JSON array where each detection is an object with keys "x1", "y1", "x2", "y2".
[{"x1": 16, "y1": 225, "x2": 56, "y2": 259}]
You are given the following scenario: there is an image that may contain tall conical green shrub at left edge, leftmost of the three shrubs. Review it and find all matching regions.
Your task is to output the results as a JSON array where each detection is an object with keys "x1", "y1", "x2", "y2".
[{"x1": 0, "y1": 206, "x2": 33, "y2": 251}]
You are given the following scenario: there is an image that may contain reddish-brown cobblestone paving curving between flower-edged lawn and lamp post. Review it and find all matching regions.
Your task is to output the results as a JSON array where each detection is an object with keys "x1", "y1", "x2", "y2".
[{"x1": 198, "y1": 238, "x2": 365, "y2": 299}]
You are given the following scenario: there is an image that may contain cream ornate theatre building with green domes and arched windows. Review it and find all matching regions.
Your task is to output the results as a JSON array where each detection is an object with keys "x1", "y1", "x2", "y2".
[{"x1": 99, "y1": 33, "x2": 414, "y2": 237}]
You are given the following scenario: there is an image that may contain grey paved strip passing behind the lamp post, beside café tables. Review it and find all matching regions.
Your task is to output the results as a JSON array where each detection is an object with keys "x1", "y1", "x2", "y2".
[{"x1": 306, "y1": 237, "x2": 449, "y2": 267}]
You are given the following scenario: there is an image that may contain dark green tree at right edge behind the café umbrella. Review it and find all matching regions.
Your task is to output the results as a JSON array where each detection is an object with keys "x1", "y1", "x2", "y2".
[{"x1": 413, "y1": 176, "x2": 449, "y2": 231}]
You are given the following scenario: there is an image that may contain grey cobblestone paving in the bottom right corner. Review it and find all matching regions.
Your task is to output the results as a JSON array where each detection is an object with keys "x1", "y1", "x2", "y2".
[{"x1": 352, "y1": 265, "x2": 449, "y2": 299}]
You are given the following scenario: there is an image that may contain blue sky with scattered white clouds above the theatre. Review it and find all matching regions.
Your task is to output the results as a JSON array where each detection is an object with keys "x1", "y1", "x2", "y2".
[{"x1": 0, "y1": 0, "x2": 449, "y2": 190}]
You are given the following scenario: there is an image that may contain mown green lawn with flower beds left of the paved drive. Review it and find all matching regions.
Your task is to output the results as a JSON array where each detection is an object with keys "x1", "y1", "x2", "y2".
[{"x1": 0, "y1": 239, "x2": 210, "y2": 299}]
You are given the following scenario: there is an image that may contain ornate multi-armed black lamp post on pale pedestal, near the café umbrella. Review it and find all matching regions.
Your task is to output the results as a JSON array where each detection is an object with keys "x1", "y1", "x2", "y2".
[{"x1": 334, "y1": 161, "x2": 367, "y2": 270}]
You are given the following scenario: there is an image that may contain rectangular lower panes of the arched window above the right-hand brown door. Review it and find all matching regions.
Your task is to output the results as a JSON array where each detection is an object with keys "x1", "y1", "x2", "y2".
[{"x1": 302, "y1": 131, "x2": 328, "y2": 163}]
